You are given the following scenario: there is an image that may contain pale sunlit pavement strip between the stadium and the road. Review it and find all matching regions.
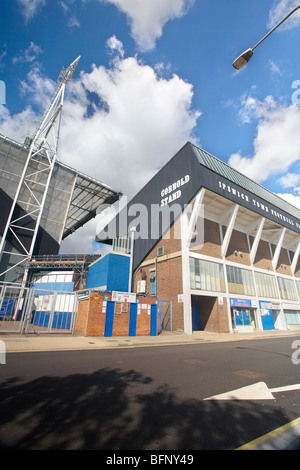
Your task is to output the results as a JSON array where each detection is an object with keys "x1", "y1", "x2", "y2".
[{"x1": 0, "y1": 330, "x2": 300, "y2": 353}]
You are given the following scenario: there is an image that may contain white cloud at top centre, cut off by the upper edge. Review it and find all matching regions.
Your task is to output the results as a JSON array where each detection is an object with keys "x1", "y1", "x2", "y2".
[{"x1": 100, "y1": 0, "x2": 194, "y2": 51}]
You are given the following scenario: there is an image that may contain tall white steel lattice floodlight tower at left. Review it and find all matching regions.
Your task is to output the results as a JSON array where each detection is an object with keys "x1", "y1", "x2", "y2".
[{"x1": 0, "y1": 56, "x2": 80, "y2": 287}]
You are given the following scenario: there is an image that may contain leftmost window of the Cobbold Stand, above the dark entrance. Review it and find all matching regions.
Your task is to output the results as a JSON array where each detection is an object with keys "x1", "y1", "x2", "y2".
[{"x1": 190, "y1": 258, "x2": 225, "y2": 292}]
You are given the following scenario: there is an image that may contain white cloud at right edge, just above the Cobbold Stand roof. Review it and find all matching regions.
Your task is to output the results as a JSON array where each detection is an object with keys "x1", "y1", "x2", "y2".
[{"x1": 229, "y1": 97, "x2": 300, "y2": 183}]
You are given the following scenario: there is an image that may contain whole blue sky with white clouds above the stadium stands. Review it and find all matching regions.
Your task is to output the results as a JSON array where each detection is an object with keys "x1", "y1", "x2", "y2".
[{"x1": 0, "y1": 0, "x2": 300, "y2": 251}]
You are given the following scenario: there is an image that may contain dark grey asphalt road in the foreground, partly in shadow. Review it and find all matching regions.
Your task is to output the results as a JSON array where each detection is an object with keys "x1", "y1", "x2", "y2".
[{"x1": 0, "y1": 337, "x2": 300, "y2": 452}]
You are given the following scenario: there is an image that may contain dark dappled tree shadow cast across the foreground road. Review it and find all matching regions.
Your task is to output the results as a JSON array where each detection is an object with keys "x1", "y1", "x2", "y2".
[{"x1": 0, "y1": 368, "x2": 294, "y2": 450}]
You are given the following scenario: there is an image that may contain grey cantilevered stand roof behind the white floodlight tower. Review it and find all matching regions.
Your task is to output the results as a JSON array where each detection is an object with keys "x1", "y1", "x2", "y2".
[{"x1": 0, "y1": 134, "x2": 121, "y2": 240}]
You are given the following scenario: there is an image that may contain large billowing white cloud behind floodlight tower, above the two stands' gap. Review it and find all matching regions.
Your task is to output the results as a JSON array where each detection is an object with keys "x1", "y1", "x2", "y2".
[{"x1": 0, "y1": 40, "x2": 200, "y2": 251}]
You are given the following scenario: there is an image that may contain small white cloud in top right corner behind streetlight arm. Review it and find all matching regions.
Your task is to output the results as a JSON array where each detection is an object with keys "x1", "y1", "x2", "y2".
[{"x1": 267, "y1": 0, "x2": 300, "y2": 31}]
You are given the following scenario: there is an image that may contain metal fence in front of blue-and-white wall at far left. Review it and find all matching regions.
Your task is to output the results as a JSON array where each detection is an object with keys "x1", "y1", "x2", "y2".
[{"x1": 0, "y1": 285, "x2": 78, "y2": 334}]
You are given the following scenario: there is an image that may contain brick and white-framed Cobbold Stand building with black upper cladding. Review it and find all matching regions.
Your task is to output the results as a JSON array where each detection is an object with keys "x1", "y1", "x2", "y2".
[{"x1": 94, "y1": 143, "x2": 300, "y2": 334}]
